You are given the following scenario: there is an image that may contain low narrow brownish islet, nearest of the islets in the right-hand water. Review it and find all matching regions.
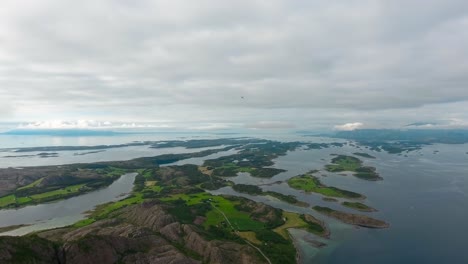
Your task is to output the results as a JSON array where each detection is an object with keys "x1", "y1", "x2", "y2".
[{"x1": 313, "y1": 206, "x2": 390, "y2": 228}]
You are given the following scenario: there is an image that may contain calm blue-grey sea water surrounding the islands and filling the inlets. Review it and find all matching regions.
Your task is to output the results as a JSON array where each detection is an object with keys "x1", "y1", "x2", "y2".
[{"x1": 0, "y1": 135, "x2": 468, "y2": 263}]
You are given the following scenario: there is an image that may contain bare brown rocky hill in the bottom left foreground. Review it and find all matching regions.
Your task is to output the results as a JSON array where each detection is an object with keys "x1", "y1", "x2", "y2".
[{"x1": 0, "y1": 202, "x2": 265, "y2": 264}]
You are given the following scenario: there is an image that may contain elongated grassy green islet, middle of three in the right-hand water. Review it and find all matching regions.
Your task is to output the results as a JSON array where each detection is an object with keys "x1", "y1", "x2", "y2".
[{"x1": 288, "y1": 174, "x2": 365, "y2": 199}]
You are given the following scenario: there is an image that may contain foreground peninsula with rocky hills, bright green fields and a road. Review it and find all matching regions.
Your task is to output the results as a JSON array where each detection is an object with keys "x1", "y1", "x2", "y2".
[{"x1": 0, "y1": 156, "x2": 329, "y2": 264}]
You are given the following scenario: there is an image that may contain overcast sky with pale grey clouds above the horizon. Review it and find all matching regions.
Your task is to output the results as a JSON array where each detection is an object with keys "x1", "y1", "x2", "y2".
[{"x1": 0, "y1": 0, "x2": 468, "y2": 130}]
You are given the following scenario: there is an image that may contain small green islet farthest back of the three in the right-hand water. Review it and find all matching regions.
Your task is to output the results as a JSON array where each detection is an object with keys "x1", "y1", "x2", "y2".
[{"x1": 325, "y1": 155, "x2": 382, "y2": 181}]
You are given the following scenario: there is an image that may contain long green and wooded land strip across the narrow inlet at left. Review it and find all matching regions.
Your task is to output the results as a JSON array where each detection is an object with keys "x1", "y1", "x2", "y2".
[{"x1": 0, "y1": 146, "x2": 235, "y2": 206}]
